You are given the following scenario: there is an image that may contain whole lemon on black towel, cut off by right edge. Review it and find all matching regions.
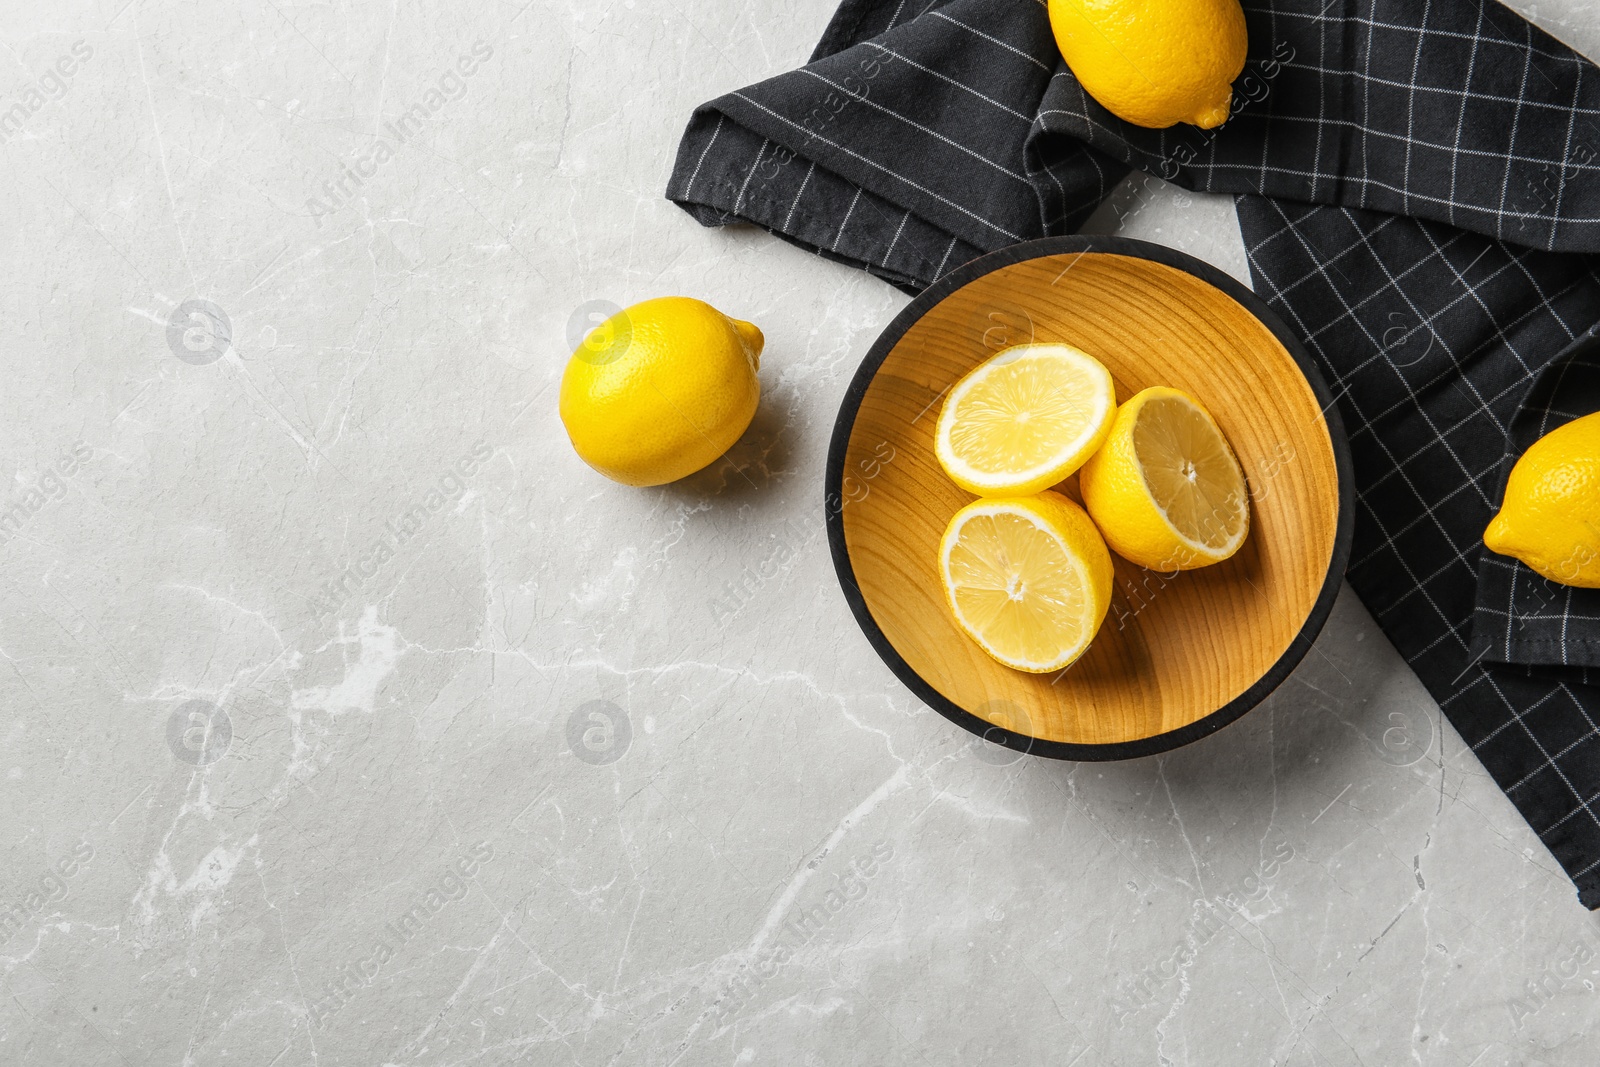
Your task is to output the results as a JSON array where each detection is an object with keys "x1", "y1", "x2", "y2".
[{"x1": 1483, "y1": 411, "x2": 1600, "y2": 589}]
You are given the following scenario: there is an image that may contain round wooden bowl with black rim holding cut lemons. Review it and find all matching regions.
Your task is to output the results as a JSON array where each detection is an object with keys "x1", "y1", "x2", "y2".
[{"x1": 826, "y1": 237, "x2": 1354, "y2": 760}]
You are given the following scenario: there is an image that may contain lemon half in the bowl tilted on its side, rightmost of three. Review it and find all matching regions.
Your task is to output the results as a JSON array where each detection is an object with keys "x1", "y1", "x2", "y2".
[{"x1": 1078, "y1": 387, "x2": 1250, "y2": 571}]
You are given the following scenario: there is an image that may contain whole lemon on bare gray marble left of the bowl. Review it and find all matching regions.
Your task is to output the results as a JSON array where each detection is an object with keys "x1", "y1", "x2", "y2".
[{"x1": 560, "y1": 296, "x2": 763, "y2": 485}]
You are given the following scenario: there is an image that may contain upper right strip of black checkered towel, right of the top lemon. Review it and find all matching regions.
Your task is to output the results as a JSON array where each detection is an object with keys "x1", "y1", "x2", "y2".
[{"x1": 1053, "y1": 0, "x2": 1600, "y2": 253}]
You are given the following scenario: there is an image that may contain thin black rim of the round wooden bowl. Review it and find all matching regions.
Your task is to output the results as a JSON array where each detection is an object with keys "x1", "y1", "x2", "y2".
[{"x1": 822, "y1": 235, "x2": 1355, "y2": 761}]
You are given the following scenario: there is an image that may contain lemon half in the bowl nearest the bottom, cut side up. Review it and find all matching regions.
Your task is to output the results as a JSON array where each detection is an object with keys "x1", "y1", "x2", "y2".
[{"x1": 939, "y1": 493, "x2": 1112, "y2": 673}]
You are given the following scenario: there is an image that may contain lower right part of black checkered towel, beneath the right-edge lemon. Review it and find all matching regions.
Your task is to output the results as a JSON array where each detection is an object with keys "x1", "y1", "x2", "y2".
[{"x1": 1240, "y1": 197, "x2": 1600, "y2": 904}]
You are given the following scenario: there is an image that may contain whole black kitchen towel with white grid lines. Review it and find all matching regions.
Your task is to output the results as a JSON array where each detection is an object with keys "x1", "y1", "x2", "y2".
[{"x1": 667, "y1": 0, "x2": 1600, "y2": 907}]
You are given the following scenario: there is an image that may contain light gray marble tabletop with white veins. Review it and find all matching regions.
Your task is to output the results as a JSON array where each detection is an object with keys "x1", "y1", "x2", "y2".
[{"x1": 0, "y1": 0, "x2": 1600, "y2": 1067}]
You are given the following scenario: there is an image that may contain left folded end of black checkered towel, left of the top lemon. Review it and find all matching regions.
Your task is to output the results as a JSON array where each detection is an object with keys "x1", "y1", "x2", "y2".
[{"x1": 667, "y1": 0, "x2": 1128, "y2": 290}]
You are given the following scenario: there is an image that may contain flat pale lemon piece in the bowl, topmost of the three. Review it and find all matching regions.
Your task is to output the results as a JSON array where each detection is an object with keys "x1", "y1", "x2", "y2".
[{"x1": 933, "y1": 344, "x2": 1117, "y2": 496}]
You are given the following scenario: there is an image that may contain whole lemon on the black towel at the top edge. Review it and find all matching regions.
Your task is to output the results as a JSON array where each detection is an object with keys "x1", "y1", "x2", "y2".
[{"x1": 1050, "y1": 0, "x2": 1246, "y2": 130}]
